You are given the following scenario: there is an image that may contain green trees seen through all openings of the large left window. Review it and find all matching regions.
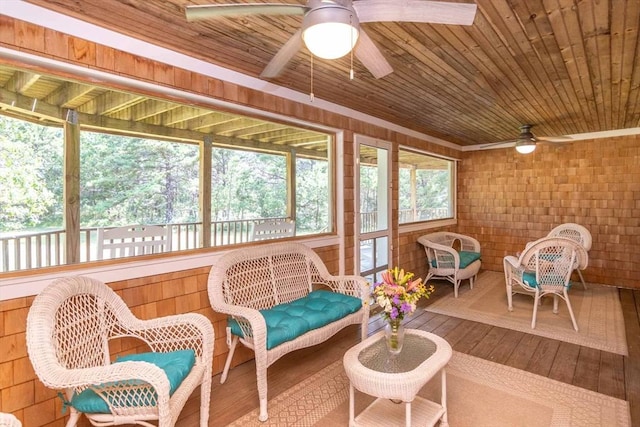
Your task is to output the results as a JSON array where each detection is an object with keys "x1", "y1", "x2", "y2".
[{"x1": 0, "y1": 115, "x2": 329, "y2": 232}]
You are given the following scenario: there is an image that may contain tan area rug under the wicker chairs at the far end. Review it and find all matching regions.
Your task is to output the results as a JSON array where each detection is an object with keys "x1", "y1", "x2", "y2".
[{"x1": 426, "y1": 271, "x2": 629, "y2": 356}]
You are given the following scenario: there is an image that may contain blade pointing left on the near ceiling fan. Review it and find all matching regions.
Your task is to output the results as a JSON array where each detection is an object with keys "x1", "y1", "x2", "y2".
[{"x1": 185, "y1": 3, "x2": 309, "y2": 21}]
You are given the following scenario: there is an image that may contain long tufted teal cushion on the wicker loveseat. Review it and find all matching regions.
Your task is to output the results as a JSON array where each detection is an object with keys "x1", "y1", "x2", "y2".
[{"x1": 229, "y1": 290, "x2": 362, "y2": 350}]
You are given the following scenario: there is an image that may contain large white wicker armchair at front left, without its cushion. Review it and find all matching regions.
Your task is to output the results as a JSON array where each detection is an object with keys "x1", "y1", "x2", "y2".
[{"x1": 27, "y1": 276, "x2": 214, "y2": 427}]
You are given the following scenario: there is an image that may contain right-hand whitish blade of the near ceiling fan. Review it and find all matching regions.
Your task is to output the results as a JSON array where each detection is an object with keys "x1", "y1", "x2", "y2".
[{"x1": 353, "y1": 0, "x2": 477, "y2": 25}]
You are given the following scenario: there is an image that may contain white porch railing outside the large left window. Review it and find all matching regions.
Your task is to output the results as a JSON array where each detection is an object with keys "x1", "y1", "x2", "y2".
[{"x1": 0, "y1": 218, "x2": 286, "y2": 273}]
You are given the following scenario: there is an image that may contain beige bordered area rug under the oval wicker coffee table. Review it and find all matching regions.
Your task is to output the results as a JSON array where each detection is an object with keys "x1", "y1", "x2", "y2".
[{"x1": 229, "y1": 352, "x2": 631, "y2": 427}]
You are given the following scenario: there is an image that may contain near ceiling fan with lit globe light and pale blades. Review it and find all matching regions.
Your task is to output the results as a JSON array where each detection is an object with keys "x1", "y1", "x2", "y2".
[{"x1": 185, "y1": 0, "x2": 477, "y2": 79}]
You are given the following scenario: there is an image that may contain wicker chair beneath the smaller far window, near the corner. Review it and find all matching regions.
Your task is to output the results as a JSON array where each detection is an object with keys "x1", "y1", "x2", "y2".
[{"x1": 418, "y1": 231, "x2": 481, "y2": 298}]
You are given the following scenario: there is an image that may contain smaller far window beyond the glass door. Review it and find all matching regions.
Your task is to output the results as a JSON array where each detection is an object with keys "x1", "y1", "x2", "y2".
[{"x1": 398, "y1": 148, "x2": 455, "y2": 224}]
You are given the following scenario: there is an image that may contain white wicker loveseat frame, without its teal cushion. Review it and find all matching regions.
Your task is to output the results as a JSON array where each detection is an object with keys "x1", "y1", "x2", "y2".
[{"x1": 208, "y1": 242, "x2": 370, "y2": 421}]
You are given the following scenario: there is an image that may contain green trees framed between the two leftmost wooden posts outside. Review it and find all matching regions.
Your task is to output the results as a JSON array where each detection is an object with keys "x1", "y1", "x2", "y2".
[{"x1": 80, "y1": 132, "x2": 199, "y2": 227}]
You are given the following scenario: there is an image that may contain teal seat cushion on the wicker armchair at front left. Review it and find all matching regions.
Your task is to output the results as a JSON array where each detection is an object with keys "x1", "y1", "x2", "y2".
[{"x1": 71, "y1": 349, "x2": 196, "y2": 414}]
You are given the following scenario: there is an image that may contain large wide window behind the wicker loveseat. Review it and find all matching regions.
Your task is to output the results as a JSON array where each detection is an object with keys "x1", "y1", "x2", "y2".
[{"x1": 0, "y1": 67, "x2": 334, "y2": 273}]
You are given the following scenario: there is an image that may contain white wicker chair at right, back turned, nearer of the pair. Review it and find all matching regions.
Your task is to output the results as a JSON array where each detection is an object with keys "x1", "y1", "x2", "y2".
[{"x1": 504, "y1": 237, "x2": 588, "y2": 331}]
